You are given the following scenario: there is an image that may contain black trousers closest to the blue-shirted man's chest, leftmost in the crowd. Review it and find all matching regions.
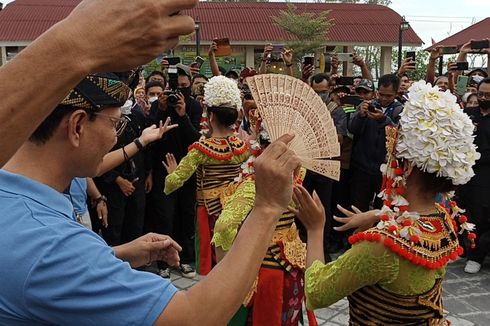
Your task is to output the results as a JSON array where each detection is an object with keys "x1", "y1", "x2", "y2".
[{"x1": 101, "y1": 178, "x2": 146, "y2": 246}]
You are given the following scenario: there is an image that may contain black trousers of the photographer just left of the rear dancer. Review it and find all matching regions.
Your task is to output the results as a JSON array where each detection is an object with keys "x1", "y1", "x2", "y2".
[{"x1": 145, "y1": 171, "x2": 196, "y2": 268}]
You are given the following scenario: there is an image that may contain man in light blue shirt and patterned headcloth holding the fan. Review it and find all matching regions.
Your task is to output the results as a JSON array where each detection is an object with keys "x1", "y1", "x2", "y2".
[{"x1": 0, "y1": 70, "x2": 300, "y2": 325}]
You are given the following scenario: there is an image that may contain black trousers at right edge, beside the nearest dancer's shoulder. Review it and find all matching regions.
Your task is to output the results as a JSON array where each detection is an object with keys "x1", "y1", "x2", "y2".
[{"x1": 458, "y1": 185, "x2": 490, "y2": 264}]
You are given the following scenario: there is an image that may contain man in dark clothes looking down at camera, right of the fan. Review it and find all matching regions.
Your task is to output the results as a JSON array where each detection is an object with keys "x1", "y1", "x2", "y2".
[{"x1": 348, "y1": 74, "x2": 403, "y2": 211}]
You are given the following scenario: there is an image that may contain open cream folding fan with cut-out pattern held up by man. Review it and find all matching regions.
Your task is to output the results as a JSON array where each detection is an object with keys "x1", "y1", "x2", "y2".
[{"x1": 247, "y1": 74, "x2": 340, "y2": 180}]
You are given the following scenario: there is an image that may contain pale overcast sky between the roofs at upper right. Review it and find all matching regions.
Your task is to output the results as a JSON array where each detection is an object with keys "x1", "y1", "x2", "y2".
[{"x1": 0, "y1": 0, "x2": 490, "y2": 46}]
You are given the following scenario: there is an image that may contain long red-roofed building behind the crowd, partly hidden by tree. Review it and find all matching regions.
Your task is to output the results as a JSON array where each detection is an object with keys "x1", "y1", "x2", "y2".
[{"x1": 0, "y1": 0, "x2": 422, "y2": 72}]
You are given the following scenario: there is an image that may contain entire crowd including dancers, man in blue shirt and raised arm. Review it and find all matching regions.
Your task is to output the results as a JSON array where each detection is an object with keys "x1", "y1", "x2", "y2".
[{"x1": 0, "y1": 0, "x2": 490, "y2": 325}]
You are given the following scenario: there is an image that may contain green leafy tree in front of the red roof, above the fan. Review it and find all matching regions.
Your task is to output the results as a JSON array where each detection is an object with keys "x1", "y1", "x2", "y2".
[{"x1": 272, "y1": 3, "x2": 333, "y2": 74}]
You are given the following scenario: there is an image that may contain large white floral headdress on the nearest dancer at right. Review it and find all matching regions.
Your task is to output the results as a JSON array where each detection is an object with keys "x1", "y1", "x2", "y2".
[{"x1": 396, "y1": 81, "x2": 480, "y2": 185}]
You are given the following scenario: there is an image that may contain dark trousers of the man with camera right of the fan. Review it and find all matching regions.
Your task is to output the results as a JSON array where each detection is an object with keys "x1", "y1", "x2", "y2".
[{"x1": 350, "y1": 169, "x2": 383, "y2": 212}]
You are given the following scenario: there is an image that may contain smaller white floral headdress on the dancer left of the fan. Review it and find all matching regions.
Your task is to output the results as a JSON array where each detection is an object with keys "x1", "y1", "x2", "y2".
[{"x1": 204, "y1": 76, "x2": 242, "y2": 110}]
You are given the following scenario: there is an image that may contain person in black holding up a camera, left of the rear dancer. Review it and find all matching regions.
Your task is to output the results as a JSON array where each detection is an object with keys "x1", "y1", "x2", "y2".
[{"x1": 145, "y1": 64, "x2": 202, "y2": 278}]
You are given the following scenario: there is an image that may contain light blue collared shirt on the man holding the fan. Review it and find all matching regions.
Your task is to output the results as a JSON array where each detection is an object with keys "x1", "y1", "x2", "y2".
[{"x1": 0, "y1": 170, "x2": 177, "y2": 325}]
